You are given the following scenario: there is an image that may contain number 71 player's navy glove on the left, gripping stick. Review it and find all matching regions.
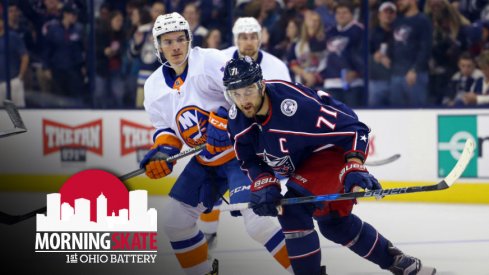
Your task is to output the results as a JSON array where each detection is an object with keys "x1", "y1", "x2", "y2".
[{"x1": 250, "y1": 173, "x2": 282, "y2": 216}]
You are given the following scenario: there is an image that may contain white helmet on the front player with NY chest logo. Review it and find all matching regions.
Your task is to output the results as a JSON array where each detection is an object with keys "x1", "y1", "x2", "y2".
[{"x1": 153, "y1": 12, "x2": 192, "y2": 62}]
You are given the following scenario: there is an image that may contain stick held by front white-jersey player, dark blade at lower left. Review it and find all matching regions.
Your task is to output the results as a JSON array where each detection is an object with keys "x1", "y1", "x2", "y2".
[{"x1": 0, "y1": 144, "x2": 205, "y2": 225}]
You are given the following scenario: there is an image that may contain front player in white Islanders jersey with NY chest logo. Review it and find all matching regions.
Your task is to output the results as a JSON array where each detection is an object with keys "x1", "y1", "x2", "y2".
[{"x1": 140, "y1": 13, "x2": 291, "y2": 275}]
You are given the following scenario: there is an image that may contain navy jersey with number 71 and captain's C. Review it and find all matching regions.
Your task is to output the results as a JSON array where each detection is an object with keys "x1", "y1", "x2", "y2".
[{"x1": 228, "y1": 80, "x2": 370, "y2": 180}]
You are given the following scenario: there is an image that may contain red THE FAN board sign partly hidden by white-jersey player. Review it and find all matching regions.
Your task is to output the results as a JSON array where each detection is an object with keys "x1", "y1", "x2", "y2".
[{"x1": 120, "y1": 119, "x2": 154, "y2": 163}]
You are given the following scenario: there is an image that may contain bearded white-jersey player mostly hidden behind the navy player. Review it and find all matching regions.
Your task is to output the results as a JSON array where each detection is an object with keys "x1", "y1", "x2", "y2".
[{"x1": 199, "y1": 17, "x2": 291, "y2": 248}]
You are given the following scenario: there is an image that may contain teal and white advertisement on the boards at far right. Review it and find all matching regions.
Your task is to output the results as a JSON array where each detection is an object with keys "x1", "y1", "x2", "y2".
[{"x1": 438, "y1": 115, "x2": 489, "y2": 178}]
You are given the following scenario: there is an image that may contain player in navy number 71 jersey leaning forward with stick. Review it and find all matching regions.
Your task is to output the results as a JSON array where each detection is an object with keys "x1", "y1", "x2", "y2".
[{"x1": 223, "y1": 58, "x2": 435, "y2": 275}]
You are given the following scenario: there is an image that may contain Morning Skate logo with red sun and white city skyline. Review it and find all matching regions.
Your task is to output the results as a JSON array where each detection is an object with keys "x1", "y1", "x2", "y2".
[{"x1": 35, "y1": 170, "x2": 157, "y2": 263}]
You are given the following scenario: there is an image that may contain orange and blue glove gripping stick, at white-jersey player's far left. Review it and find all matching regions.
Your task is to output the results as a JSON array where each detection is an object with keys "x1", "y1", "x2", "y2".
[{"x1": 139, "y1": 145, "x2": 180, "y2": 179}]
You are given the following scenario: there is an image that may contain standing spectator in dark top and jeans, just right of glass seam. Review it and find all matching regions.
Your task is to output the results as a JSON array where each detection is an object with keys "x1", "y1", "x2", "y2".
[{"x1": 368, "y1": 2, "x2": 397, "y2": 107}]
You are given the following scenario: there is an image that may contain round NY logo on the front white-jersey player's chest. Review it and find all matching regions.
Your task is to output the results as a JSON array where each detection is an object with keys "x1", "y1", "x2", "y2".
[{"x1": 175, "y1": 106, "x2": 209, "y2": 147}]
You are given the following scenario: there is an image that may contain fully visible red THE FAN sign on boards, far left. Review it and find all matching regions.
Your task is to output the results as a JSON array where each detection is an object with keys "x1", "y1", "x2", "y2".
[{"x1": 42, "y1": 119, "x2": 103, "y2": 162}]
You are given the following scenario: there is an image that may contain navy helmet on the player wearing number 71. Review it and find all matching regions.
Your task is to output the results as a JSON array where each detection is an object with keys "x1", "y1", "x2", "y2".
[{"x1": 222, "y1": 56, "x2": 263, "y2": 90}]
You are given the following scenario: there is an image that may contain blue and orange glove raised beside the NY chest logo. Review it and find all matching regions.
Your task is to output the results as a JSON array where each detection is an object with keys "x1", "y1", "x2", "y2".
[{"x1": 205, "y1": 107, "x2": 232, "y2": 155}]
